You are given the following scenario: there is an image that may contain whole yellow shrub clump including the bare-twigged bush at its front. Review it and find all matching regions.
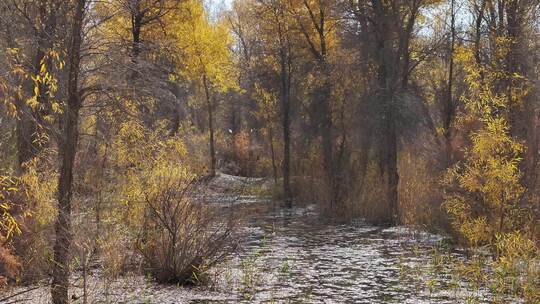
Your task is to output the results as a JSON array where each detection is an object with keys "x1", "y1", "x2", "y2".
[{"x1": 99, "y1": 121, "x2": 238, "y2": 284}]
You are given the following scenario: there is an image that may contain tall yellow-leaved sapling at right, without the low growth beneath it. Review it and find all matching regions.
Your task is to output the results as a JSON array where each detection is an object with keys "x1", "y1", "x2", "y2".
[{"x1": 444, "y1": 39, "x2": 527, "y2": 245}]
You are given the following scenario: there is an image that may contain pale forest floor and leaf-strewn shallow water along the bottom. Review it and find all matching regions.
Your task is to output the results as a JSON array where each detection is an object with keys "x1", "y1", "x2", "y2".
[{"x1": 0, "y1": 174, "x2": 500, "y2": 304}]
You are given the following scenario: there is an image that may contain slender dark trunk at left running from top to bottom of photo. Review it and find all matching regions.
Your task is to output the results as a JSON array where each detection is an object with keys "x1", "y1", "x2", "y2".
[{"x1": 51, "y1": 0, "x2": 86, "y2": 304}]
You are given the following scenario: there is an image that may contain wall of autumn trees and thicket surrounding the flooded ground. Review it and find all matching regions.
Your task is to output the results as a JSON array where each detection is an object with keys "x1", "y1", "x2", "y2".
[{"x1": 0, "y1": 0, "x2": 540, "y2": 303}]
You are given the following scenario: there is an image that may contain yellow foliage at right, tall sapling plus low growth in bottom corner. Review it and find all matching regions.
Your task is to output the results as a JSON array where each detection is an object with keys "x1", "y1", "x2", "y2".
[{"x1": 443, "y1": 37, "x2": 540, "y2": 303}]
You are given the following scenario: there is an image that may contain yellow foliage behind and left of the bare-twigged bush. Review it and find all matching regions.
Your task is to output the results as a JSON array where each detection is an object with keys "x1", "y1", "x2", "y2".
[{"x1": 108, "y1": 120, "x2": 194, "y2": 242}]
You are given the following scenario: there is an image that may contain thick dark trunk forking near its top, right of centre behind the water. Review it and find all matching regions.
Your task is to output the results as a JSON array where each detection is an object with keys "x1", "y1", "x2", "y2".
[{"x1": 371, "y1": 0, "x2": 422, "y2": 225}]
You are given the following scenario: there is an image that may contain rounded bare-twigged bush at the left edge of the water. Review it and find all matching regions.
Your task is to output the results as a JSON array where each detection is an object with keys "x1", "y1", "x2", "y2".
[{"x1": 138, "y1": 177, "x2": 236, "y2": 284}]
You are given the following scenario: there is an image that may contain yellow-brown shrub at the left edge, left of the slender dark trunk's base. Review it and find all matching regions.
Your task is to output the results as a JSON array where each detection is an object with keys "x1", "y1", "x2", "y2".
[{"x1": 0, "y1": 157, "x2": 56, "y2": 283}]
